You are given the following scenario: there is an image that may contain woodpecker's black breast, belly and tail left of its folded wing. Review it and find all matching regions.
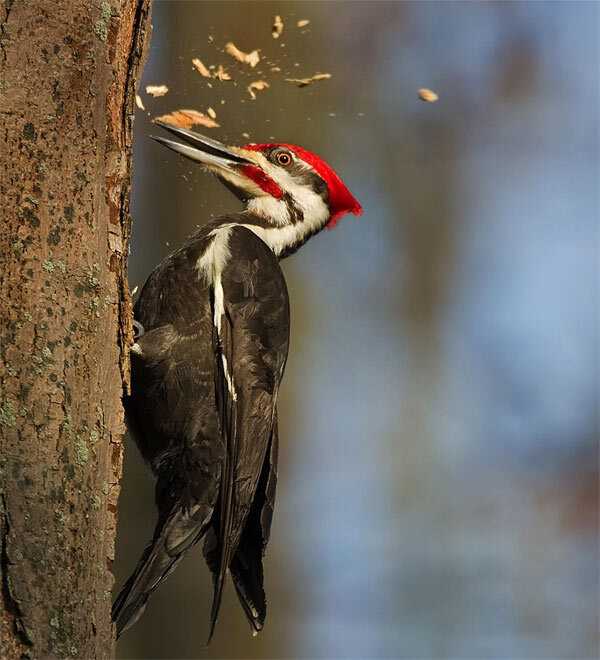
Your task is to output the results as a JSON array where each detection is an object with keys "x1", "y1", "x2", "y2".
[{"x1": 113, "y1": 235, "x2": 224, "y2": 634}]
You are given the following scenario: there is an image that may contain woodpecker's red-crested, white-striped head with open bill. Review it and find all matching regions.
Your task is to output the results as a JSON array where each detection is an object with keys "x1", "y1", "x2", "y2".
[{"x1": 154, "y1": 122, "x2": 362, "y2": 250}]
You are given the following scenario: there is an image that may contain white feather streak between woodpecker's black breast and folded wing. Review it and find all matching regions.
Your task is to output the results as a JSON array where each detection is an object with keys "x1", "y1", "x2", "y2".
[{"x1": 196, "y1": 225, "x2": 237, "y2": 401}]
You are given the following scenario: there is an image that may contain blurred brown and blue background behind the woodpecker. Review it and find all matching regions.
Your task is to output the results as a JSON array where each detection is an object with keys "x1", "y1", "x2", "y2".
[{"x1": 115, "y1": 1, "x2": 600, "y2": 658}]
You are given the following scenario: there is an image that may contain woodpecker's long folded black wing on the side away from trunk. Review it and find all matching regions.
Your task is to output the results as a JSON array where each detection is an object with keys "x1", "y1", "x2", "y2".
[{"x1": 205, "y1": 227, "x2": 289, "y2": 636}]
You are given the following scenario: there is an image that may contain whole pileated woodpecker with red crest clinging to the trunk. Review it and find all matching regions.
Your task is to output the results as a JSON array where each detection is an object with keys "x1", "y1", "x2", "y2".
[{"x1": 113, "y1": 124, "x2": 362, "y2": 641}]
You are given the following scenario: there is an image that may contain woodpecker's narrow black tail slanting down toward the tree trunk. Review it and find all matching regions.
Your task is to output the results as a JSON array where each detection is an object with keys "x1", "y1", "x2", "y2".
[{"x1": 112, "y1": 504, "x2": 213, "y2": 637}]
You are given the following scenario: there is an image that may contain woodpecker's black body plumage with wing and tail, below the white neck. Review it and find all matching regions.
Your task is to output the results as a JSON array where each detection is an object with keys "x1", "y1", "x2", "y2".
[{"x1": 113, "y1": 217, "x2": 289, "y2": 636}]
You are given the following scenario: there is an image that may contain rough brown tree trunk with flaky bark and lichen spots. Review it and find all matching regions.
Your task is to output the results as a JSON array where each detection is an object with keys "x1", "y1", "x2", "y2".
[{"x1": 0, "y1": 0, "x2": 150, "y2": 658}]
